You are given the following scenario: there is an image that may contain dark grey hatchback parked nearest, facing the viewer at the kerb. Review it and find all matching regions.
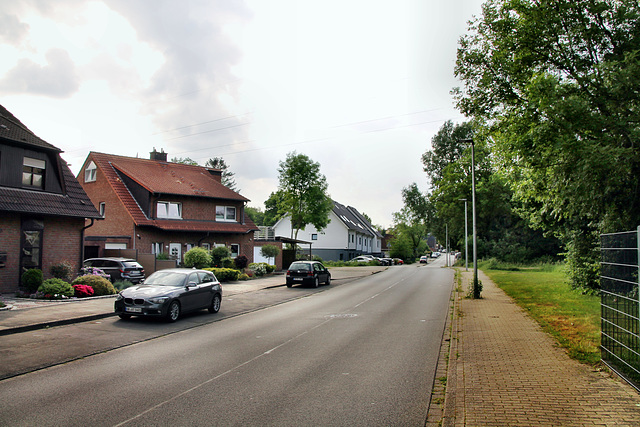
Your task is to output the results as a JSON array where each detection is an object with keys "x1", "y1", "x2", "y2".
[{"x1": 114, "y1": 268, "x2": 222, "y2": 322}]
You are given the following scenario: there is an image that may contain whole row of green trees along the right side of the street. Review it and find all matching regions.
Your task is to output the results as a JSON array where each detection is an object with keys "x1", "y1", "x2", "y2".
[{"x1": 390, "y1": 0, "x2": 640, "y2": 290}]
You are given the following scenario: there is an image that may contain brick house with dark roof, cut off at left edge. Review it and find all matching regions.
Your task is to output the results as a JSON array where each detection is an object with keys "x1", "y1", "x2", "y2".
[{"x1": 0, "y1": 105, "x2": 99, "y2": 292}]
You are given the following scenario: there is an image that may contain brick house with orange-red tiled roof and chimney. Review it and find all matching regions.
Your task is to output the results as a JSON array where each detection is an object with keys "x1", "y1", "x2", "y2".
[{"x1": 78, "y1": 149, "x2": 258, "y2": 262}]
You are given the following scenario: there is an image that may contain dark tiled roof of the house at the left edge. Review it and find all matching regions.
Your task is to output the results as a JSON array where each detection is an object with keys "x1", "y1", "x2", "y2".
[{"x1": 0, "y1": 105, "x2": 100, "y2": 218}]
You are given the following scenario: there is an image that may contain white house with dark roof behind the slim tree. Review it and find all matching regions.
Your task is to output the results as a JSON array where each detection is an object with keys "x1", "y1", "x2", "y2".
[{"x1": 273, "y1": 201, "x2": 382, "y2": 261}]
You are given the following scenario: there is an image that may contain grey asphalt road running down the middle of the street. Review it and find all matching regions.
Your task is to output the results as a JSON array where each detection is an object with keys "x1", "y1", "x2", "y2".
[{"x1": 0, "y1": 263, "x2": 453, "y2": 426}]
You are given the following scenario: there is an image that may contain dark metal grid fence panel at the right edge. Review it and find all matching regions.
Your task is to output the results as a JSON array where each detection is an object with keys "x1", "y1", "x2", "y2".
[{"x1": 600, "y1": 227, "x2": 640, "y2": 390}]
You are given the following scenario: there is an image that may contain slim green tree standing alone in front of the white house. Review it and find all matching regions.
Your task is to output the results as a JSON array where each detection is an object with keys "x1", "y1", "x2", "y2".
[{"x1": 278, "y1": 152, "x2": 333, "y2": 239}]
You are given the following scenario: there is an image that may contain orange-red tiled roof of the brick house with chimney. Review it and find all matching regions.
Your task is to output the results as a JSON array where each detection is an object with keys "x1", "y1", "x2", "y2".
[{"x1": 86, "y1": 151, "x2": 258, "y2": 234}]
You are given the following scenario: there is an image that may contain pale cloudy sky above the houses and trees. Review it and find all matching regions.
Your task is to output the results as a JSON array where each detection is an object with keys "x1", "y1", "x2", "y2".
[{"x1": 0, "y1": 0, "x2": 482, "y2": 227}]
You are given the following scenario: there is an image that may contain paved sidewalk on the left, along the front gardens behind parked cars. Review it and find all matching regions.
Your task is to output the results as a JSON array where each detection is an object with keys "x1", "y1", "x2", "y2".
[{"x1": 0, "y1": 267, "x2": 387, "y2": 336}]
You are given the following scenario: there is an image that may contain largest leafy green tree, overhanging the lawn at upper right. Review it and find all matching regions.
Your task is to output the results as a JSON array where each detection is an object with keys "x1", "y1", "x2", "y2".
[{"x1": 454, "y1": 0, "x2": 640, "y2": 288}]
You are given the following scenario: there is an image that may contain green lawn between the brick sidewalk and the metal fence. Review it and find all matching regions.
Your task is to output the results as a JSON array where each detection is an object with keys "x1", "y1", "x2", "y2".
[{"x1": 479, "y1": 264, "x2": 600, "y2": 364}]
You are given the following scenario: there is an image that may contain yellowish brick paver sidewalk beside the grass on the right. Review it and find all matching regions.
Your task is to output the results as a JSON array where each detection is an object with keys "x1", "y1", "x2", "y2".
[{"x1": 443, "y1": 270, "x2": 640, "y2": 426}]
